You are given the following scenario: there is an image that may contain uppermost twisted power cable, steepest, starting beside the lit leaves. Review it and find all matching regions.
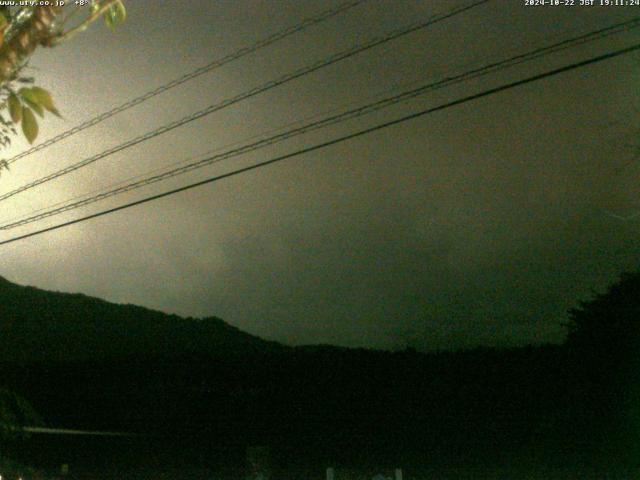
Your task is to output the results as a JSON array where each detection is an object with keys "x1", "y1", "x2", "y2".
[{"x1": 2, "y1": 0, "x2": 367, "y2": 164}]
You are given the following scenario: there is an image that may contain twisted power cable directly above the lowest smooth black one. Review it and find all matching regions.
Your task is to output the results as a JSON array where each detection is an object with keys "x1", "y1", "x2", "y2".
[{"x1": 0, "y1": 17, "x2": 640, "y2": 230}]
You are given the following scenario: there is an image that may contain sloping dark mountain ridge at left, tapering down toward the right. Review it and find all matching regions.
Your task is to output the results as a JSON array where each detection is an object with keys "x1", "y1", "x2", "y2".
[{"x1": 0, "y1": 276, "x2": 290, "y2": 361}]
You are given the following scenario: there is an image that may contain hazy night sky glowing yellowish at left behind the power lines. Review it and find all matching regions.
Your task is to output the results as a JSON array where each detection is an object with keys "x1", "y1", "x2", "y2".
[{"x1": 0, "y1": 0, "x2": 640, "y2": 350}]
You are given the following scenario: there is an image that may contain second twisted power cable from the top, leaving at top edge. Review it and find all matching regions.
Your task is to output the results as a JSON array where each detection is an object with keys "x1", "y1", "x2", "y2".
[{"x1": 0, "y1": 0, "x2": 490, "y2": 201}]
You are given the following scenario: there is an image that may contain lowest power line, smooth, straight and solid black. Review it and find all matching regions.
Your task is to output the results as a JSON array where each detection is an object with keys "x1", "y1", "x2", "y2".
[{"x1": 0, "y1": 44, "x2": 640, "y2": 245}]
